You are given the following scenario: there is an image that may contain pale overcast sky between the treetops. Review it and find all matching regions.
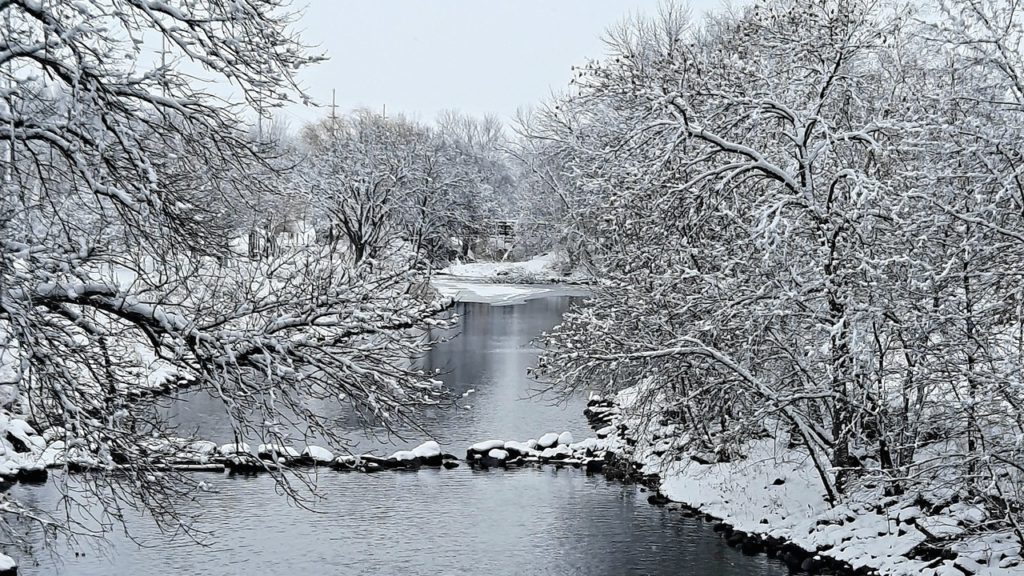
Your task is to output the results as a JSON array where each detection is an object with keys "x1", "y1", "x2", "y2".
[{"x1": 284, "y1": 0, "x2": 721, "y2": 127}]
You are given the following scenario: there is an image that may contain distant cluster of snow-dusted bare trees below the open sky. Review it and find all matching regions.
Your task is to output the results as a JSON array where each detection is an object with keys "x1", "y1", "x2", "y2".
[{"x1": 304, "y1": 110, "x2": 512, "y2": 262}]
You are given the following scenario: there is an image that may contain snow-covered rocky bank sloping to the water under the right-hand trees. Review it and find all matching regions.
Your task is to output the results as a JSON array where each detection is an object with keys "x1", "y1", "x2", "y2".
[{"x1": 588, "y1": 389, "x2": 1024, "y2": 576}]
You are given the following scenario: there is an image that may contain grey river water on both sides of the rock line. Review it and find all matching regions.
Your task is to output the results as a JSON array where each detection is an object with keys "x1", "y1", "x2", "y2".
[{"x1": 8, "y1": 297, "x2": 785, "y2": 576}]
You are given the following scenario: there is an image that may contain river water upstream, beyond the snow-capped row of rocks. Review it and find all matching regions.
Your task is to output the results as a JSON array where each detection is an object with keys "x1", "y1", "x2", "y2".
[{"x1": 160, "y1": 296, "x2": 588, "y2": 454}]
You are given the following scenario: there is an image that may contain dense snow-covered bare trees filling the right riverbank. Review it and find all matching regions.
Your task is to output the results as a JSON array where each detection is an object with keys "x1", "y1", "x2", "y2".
[{"x1": 528, "y1": 0, "x2": 1024, "y2": 569}]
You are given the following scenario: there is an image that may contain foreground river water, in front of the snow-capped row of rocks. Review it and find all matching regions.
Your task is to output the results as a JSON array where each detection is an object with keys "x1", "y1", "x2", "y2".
[{"x1": 12, "y1": 468, "x2": 783, "y2": 576}]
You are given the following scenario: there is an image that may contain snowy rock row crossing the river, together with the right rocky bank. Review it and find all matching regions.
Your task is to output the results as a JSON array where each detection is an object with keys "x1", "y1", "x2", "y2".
[{"x1": 12, "y1": 368, "x2": 1024, "y2": 576}]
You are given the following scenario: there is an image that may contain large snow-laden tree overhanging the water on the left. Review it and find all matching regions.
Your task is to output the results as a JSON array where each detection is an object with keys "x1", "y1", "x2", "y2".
[{"x1": 0, "y1": 0, "x2": 444, "y2": 545}]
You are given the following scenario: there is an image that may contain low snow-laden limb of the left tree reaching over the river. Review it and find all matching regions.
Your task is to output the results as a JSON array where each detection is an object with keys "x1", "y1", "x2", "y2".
[{"x1": 4, "y1": 243, "x2": 445, "y2": 440}]
